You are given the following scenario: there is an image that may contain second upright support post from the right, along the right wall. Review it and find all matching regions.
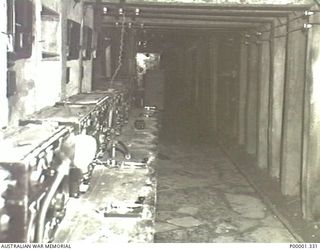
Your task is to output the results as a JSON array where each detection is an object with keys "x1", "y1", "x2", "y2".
[{"x1": 280, "y1": 13, "x2": 306, "y2": 195}]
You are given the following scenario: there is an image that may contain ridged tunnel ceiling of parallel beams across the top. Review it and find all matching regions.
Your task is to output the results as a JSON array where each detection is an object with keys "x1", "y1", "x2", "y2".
[{"x1": 86, "y1": 0, "x2": 315, "y2": 52}]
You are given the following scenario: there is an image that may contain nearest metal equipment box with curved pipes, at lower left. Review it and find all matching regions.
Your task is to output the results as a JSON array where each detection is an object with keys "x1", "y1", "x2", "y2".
[{"x1": 0, "y1": 124, "x2": 71, "y2": 242}]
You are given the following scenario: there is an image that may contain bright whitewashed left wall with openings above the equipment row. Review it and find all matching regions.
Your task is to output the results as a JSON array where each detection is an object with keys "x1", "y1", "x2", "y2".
[{"x1": 0, "y1": 0, "x2": 94, "y2": 126}]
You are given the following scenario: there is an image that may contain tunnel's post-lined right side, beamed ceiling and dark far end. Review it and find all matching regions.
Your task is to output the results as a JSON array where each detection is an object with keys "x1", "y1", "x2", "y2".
[{"x1": 95, "y1": 0, "x2": 320, "y2": 241}]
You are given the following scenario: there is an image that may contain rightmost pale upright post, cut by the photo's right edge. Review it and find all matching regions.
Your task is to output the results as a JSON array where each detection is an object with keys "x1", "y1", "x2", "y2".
[{"x1": 302, "y1": 7, "x2": 320, "y2": 220}]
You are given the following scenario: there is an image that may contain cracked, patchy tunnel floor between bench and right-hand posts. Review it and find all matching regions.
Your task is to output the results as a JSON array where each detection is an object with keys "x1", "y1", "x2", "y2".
[{"x1": 155, "y1": 109, "x2": 296, "y2": 243}]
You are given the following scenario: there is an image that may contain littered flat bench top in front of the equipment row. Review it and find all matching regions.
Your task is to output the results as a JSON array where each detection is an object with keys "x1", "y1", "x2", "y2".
[{"x1": 55, "y1": 109, "x2": 159, "y2": 243}]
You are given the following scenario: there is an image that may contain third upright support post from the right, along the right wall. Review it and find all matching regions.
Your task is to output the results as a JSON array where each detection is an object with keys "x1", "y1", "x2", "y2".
[{"x1": 268, "y1": 18, "x2": 287, "y2": 178}]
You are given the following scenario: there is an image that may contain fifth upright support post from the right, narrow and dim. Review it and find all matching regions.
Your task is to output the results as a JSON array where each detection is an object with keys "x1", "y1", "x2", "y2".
[{"x1": 246, "y1": 41, "x2": 258, "y2": 155}]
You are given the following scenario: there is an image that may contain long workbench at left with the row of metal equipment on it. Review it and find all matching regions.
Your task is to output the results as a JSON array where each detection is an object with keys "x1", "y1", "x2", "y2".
[{"x1": 0, "y1": 88, "x2": 158, "y2": 242}]
